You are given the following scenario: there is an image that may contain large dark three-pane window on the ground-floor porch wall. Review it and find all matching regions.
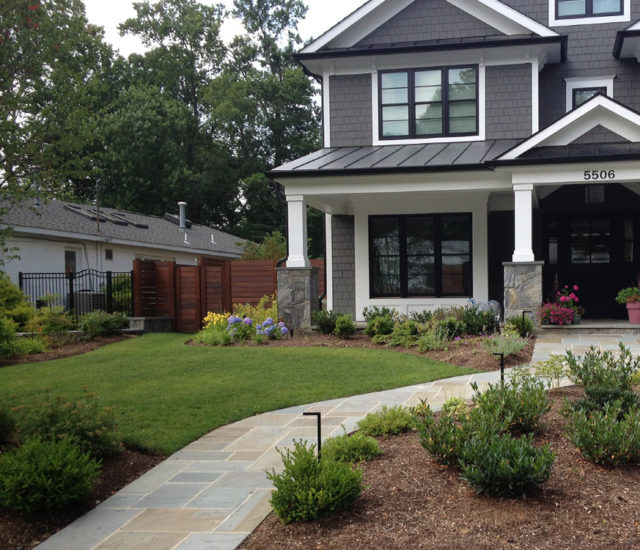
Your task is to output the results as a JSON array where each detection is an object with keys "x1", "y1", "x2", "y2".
[{"x1": 369, "y1": 214, "x2": 472, "y2": 298}]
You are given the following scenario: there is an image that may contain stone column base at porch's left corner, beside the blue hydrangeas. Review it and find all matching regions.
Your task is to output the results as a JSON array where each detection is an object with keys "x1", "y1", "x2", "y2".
[{"x1": 276, "y1": 267, "x2": 319, "y2": 331}]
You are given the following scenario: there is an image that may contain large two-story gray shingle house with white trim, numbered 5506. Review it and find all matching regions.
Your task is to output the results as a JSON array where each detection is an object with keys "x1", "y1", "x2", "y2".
[{"x1": 270, "y1": 0, "x2": 640, "y2": 320}]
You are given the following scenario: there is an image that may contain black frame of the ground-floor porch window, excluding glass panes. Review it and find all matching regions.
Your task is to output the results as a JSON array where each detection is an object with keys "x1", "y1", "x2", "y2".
[{"x1": 368, "y1": 212, "x2": 473, "y2": 298}]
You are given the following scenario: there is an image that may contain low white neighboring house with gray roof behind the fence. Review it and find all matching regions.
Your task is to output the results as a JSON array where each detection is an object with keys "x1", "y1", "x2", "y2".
[{"x1": 0, "y1": 200, "x2": 245, "y2": 283}]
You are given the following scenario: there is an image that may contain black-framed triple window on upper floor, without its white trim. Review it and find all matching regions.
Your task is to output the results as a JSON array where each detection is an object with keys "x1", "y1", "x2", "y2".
[{"x1": 378, "y1": 66, "x2": 478, "y2": 139}]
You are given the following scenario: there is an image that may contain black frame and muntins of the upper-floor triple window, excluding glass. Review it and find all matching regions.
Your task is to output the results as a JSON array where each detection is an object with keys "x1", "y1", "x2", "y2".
[{"x1": 378, "y1": 63, "x2": 480, "y2": 141}]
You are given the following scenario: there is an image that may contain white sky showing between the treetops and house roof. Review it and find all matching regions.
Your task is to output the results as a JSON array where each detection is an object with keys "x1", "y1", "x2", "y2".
[{"x1": 84, "y1": 0, "x2": 365, "y2": 57}]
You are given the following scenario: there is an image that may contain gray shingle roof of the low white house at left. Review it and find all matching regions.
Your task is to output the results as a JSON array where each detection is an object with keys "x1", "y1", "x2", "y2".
[{"x1": 0, "y1": 200, "x2": 246, "y2": 257}]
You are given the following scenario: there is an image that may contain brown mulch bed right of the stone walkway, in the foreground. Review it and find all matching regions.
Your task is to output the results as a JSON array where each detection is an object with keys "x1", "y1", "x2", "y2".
[{"x1": 242, "y1": 388, "x2": 640, "y2": 550}]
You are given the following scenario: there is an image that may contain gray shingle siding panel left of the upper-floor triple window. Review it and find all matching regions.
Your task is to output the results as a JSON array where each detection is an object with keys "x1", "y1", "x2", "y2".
[{"x1": 329, "y1": 74, "x2": 373, "y2": 147}]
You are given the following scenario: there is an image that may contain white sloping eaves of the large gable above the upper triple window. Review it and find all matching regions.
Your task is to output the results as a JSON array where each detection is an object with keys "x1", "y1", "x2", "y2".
[{"x1": 300, "y1": 0, "x2": 558, "y2": 56}]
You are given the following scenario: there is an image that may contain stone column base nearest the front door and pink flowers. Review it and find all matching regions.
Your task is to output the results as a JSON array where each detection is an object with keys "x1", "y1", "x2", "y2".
[{"x1": 502, "y1": 262, "x2": 544, "y2": 320}]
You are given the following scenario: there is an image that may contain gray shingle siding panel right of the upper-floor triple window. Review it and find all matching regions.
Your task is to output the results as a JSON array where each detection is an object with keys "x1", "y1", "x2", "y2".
[{"x1": 485, "y1": 64, "x2": 532, "y2": 139}]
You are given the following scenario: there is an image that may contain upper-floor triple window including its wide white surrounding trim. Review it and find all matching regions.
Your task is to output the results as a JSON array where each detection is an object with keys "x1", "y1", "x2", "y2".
[{"x1": 372, "y1": 64, "x2": 485, "y2": 145}]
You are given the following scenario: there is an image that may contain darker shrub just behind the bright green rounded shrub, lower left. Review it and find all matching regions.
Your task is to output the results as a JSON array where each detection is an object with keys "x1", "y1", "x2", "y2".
[{"x1": 19, "y1": 388, "x2": 122, "y2": 459}]
